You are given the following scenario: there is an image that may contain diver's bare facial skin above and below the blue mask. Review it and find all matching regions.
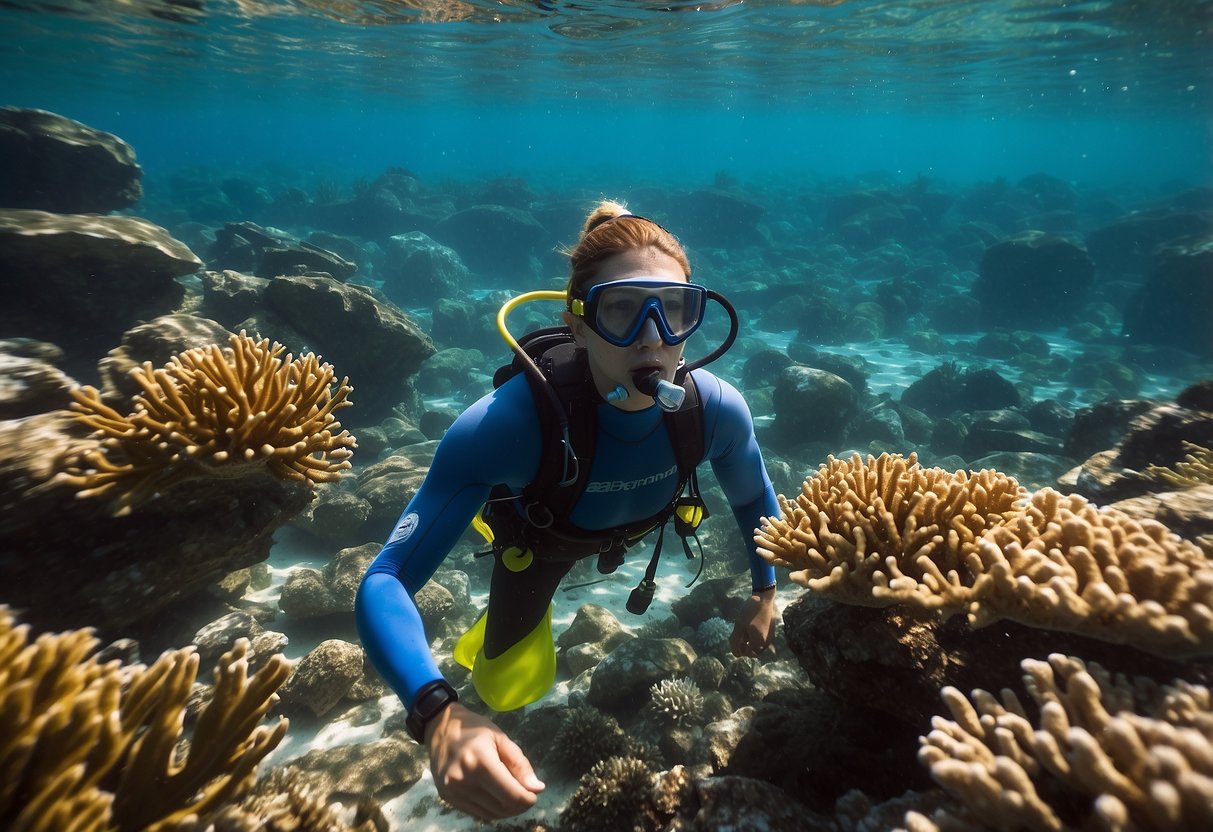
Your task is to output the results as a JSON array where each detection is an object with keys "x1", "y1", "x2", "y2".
[{"x1": 564, "y1": 249, "x2": 687, "y2": 410}]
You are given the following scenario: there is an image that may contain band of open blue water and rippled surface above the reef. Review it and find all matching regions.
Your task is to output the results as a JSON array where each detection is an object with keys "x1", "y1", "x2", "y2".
[{"x1": 0, "y1": 0, "x2": 1213, "y2": 189}]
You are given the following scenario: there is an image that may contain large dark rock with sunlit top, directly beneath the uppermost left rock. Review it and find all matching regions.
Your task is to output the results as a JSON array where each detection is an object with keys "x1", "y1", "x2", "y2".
[{"x1": 0, "y1": 210, "x2": 203, "y2": 371}]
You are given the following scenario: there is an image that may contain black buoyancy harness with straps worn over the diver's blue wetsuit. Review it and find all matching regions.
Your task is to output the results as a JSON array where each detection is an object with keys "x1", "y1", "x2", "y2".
[{"x1": 475, "y1": 326, "x2": 708, "y2": 615}]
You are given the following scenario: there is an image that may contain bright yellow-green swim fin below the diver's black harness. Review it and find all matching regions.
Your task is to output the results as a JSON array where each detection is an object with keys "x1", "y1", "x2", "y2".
[{"x1": 454, "y1": 604, "x2": 556, "y2": 711}]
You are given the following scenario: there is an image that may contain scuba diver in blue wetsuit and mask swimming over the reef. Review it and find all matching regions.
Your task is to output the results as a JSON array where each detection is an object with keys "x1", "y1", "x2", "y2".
[{"x1": 355, "y1": 201, "x2": 779, "y2": 820}]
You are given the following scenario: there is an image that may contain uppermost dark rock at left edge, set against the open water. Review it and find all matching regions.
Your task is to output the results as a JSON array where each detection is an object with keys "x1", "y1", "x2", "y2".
[{"x1": 0, "y1": 107, "x2": 143, "y2": 213}]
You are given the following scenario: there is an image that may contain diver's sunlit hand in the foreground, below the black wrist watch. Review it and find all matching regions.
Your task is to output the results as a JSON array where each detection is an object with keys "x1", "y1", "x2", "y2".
[{"x1": 426, "y1": 702, "x2": 543, "y2": 820}]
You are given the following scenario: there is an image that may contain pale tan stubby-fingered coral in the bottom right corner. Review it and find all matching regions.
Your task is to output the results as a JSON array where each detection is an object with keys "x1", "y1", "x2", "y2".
[{"x1": 906, "y1": 654, "x2": 1213, "y2": 832}]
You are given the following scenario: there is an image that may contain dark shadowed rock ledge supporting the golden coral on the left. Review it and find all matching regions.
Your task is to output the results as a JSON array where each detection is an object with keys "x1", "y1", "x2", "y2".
[{"x1": 0, "y1": 411, "x2": 312, "y2": 636}]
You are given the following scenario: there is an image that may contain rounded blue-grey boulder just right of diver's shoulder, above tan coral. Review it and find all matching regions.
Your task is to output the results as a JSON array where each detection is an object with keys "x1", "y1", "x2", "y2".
[{"x1": 770, "y1": 365, "x2": 859, "y2": 448}]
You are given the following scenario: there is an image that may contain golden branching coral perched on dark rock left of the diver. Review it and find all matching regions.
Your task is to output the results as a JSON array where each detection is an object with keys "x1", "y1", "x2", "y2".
[{"x1": 61, "y1": 331, "x2": 357, "y2": 514}]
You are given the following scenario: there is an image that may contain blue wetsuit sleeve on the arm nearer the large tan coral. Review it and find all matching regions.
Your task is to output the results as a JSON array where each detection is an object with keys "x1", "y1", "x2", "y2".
[{"x1": 695, "y1": 371, "x2": 779, "y2": 592}]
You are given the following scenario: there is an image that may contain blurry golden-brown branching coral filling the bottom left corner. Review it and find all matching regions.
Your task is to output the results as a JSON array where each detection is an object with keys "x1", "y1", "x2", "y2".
[{"x1": 0, "y1": 608, "x2": 290, "y2": 830}]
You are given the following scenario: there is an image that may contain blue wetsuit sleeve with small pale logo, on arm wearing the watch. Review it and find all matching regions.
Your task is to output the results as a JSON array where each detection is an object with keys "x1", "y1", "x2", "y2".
[{"x1": 354, "y1": 376, "x2": 540, "y2": 707}]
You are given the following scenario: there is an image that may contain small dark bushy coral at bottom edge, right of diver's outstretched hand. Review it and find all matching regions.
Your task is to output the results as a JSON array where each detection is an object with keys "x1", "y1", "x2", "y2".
[{"x1": 560, "y1": 757, "x2": 662, "y2": 832}]
